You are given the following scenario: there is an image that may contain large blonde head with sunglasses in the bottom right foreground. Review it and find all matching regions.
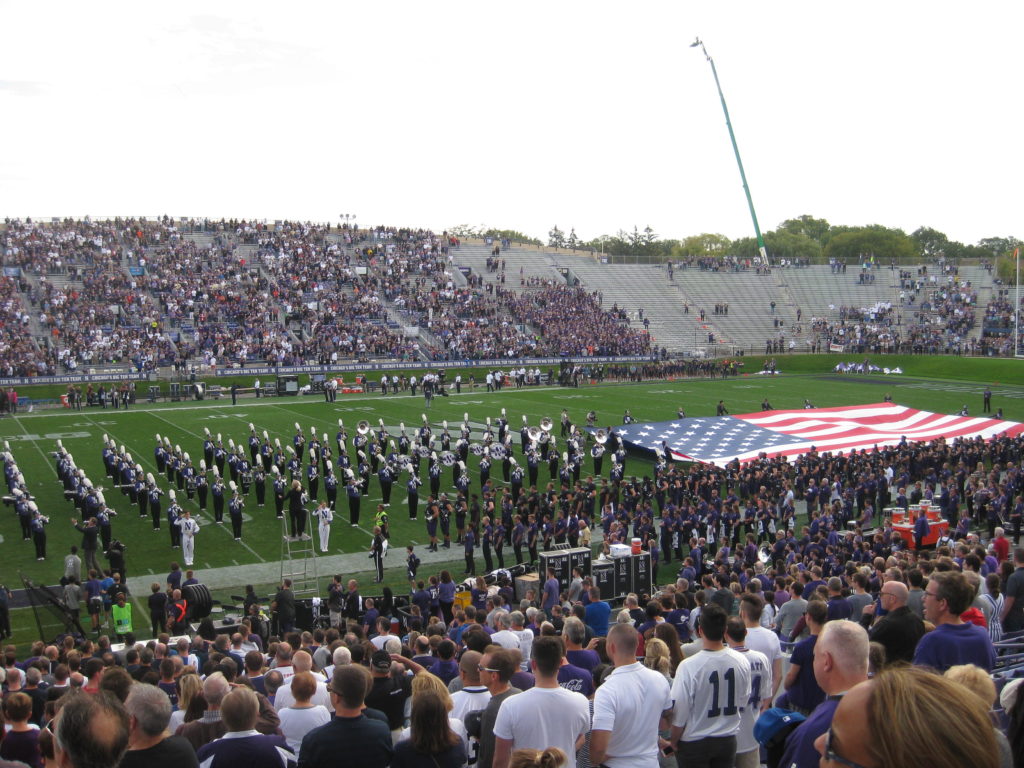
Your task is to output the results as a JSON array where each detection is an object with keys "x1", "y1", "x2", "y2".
[{"x1": 814, "y1": 667, "x2": 999, "y2": 768}]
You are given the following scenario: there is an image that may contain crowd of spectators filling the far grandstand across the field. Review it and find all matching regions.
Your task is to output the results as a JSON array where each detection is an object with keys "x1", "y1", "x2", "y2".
[{"x1": 2, "y1": 217, "x2": 1011, "y2": 373}]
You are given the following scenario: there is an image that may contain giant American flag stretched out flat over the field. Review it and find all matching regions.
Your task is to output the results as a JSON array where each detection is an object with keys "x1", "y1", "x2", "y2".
[{"x1": 612, "y1": 402, "x2": 1024, "y2": 466}]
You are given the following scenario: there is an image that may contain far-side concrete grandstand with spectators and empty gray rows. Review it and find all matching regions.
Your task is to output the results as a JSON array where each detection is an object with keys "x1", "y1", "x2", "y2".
[{"x1": 0, "y1": 217, "x2": 1024, "y2": 376}]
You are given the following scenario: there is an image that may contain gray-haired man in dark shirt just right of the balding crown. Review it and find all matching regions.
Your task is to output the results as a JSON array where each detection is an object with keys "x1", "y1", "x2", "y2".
[{"x1": 119, "y1": 683, "x2": 199, "y2": 768}]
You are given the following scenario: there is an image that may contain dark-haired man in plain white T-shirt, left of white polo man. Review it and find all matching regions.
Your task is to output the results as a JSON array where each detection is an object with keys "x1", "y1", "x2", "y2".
[{"x1": 493, "y1": 636, "x2": 590, "y2": 768}]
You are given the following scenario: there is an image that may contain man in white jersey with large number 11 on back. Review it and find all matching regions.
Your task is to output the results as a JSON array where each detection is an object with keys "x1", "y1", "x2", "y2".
[{"x1": 670, "y1": 603, "x2": 751, "y2": 768}]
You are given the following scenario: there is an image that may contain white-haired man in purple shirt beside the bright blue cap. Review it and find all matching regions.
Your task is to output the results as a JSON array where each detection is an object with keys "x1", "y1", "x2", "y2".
[{"x1": 779, "y1": 621, "x2": 869, "y2": 767}]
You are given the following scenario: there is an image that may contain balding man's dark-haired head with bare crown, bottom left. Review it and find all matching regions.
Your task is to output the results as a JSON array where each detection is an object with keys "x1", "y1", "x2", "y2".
[{"x1": 53, "y1": 691, "x2": 128, "y2": 768}]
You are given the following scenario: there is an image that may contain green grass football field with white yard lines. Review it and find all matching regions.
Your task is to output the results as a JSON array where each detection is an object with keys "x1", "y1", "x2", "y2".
[{"x1": 0, "y1": 358, "x2": 1024, "y2": 642}]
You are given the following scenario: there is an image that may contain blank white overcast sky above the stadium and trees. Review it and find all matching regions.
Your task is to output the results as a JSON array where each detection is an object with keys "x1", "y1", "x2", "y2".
[{"x1": 0, "y1": 0, "x2": 1024, "y2": 243}]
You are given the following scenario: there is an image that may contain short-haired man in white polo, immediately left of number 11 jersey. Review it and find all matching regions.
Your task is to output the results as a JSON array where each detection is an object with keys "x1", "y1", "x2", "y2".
[{"x1": 590, "y1": 624, "x2": 672, "y2": 768}]
